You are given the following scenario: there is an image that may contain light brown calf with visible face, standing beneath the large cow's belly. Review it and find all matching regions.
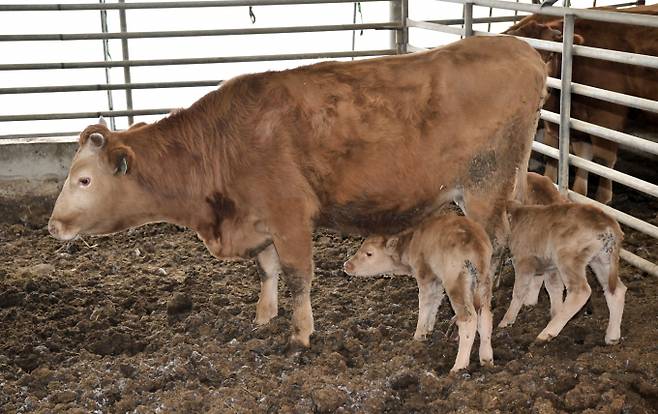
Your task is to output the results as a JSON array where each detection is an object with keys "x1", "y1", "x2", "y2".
[{"x1": 345, "y1": 214, "x2": 493, "y2": 372}]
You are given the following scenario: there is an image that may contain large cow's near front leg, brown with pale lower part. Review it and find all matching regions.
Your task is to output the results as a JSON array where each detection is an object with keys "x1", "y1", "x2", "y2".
[{"x1": 274, "y1": 225, "x2": 313, "y2": 347}]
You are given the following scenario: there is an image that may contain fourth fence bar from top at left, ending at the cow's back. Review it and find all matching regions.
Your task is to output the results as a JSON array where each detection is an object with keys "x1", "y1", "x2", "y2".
[{"x1": 0, "y1": 80, "x2": 223, "y2": 95}]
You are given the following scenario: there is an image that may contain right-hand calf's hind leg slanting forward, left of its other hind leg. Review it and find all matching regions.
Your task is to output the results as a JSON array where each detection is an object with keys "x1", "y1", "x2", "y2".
[{"x1": 537, "y1": 251, "x2": 592, "y2": 341}]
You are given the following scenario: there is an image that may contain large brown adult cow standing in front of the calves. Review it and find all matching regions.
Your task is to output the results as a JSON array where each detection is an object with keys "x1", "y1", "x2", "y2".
[{"x1": 49, "y1": 37, "x2": 546, "y2": 346}]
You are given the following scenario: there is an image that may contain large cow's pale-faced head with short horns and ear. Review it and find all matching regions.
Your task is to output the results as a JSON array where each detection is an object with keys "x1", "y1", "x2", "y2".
[{"x1": 48, "y1": 118, "x2": 149, "y2": 240}]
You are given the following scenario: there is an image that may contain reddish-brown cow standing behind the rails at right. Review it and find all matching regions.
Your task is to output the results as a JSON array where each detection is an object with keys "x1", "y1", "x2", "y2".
[{"x1": 505, "y1": 5, "x2": 658, "y2": 203}]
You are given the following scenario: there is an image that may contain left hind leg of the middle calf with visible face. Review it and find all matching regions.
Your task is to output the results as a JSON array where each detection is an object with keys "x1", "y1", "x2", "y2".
[{"x1": 444, "y1": 268, "x2": 478, "y2": 372}]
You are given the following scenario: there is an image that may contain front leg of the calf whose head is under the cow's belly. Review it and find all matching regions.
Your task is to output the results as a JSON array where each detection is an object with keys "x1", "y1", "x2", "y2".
[{"x1": 414, "y1": 269, "x2": 443, "y2": 341}]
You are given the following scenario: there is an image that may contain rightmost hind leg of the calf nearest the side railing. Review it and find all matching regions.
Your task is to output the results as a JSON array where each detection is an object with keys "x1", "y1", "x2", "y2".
[{"x1": 590, "y1": 253, "x2": 626, "y2": 345}]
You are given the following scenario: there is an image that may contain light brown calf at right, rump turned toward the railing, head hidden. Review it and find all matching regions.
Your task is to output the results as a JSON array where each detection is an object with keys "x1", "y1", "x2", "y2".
[{"x1": 499, "y1": 201, "x2": 626, "y2": 344}]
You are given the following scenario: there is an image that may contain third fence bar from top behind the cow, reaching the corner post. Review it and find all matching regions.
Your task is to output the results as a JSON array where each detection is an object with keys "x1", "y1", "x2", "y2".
[{"x1": 0, "y1": 49, "x2": 396, "y2": 70}]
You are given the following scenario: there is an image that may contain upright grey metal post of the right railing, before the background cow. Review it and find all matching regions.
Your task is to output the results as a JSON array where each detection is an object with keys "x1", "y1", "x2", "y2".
[{"x1": 557, "y1": 14, "x2": 575, "y2": 196}]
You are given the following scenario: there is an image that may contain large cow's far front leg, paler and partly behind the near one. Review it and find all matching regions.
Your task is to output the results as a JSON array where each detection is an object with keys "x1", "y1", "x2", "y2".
[{"x1": 254, "y1": 244, "x2": 281, "y2": 325}]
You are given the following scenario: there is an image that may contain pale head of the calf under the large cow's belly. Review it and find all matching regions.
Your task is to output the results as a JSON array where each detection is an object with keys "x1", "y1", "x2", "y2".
[{"x1": 343, "y1": 236, "x2": 401, "y2": 276}]
